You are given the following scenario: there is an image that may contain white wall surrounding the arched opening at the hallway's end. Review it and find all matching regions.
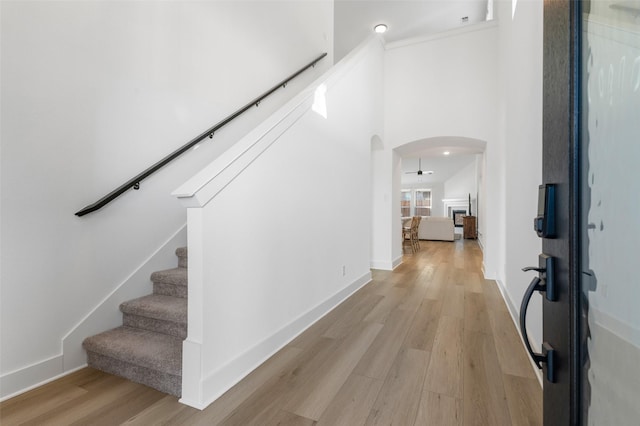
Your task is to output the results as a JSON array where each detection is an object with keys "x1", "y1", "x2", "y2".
[{"x1": 373, "y1": 23, "x2": 502, "y2": 272}]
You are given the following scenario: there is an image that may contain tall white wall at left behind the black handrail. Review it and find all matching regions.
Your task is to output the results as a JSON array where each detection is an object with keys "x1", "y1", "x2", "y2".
[{"x1": 0, "y1": 1, "x2": 333, "y2": 396}]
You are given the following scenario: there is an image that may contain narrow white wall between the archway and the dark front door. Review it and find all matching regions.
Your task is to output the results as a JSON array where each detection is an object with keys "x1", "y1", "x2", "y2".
[{"x1": 497, "y1": 1, "x2": 543, "y2": 347}]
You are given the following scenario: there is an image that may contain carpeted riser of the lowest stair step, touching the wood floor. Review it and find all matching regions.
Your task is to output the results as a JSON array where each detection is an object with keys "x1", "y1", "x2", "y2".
[{"x1": 87, "y1": 351, "x2": 182, "y2": 397}]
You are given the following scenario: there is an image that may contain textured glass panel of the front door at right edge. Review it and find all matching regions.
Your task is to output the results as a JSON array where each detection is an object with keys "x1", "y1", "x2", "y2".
[{"x1": 581, "y1": 1, "x2": 640, "y2": 425}]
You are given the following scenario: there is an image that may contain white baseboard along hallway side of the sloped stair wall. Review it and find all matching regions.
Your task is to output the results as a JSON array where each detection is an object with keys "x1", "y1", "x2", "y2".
[{"x1": 180, "y1": 272, "x2": 371, "y2": 410}]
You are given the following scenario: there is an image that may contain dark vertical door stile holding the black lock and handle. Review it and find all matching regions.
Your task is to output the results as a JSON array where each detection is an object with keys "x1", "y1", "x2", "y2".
[{"x1": 542, "y1": 0, "x2": 579, "y2": 426}]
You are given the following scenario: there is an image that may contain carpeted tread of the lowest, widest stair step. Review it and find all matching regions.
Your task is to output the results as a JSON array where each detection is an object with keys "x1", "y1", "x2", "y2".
[{"x1": 82, "y1": 327, "x2": 182, "y2": 376}]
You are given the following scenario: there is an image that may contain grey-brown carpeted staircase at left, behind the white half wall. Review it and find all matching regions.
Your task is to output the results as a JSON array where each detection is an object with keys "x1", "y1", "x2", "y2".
[{"x1": 82, "y1": 247, "x2": 187, "y2": 396}]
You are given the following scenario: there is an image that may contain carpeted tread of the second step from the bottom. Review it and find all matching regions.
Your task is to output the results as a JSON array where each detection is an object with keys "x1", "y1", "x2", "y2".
[{"x1": 120, "y1": 294, "x2": 187, "y2": 324}]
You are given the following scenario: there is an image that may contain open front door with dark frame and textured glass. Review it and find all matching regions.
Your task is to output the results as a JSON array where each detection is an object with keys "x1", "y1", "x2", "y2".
[{"x1": 532, "y1": 0, "x2": 640, "y2": 425}]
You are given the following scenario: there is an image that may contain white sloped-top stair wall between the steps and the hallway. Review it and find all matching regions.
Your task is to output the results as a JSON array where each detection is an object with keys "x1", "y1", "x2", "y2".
[{"x1": 175, "y1": 38, "x2": 383, "y2": 408}]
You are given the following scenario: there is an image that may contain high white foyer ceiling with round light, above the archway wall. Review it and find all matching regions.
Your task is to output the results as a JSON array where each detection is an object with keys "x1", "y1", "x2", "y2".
[{"x1": 334, "y1": 0, "x2": 487, "y2": 59}]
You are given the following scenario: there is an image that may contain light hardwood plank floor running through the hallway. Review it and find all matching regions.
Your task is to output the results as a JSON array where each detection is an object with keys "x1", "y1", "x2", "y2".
[{"x1": 0, "y1": 240, "x2": 542, "y2": 426}]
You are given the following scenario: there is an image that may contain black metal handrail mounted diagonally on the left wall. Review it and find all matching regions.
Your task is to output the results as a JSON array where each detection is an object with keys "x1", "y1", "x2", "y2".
[{"x1": 76, "y1": 53, "x2": 327, "y2": 216}]
